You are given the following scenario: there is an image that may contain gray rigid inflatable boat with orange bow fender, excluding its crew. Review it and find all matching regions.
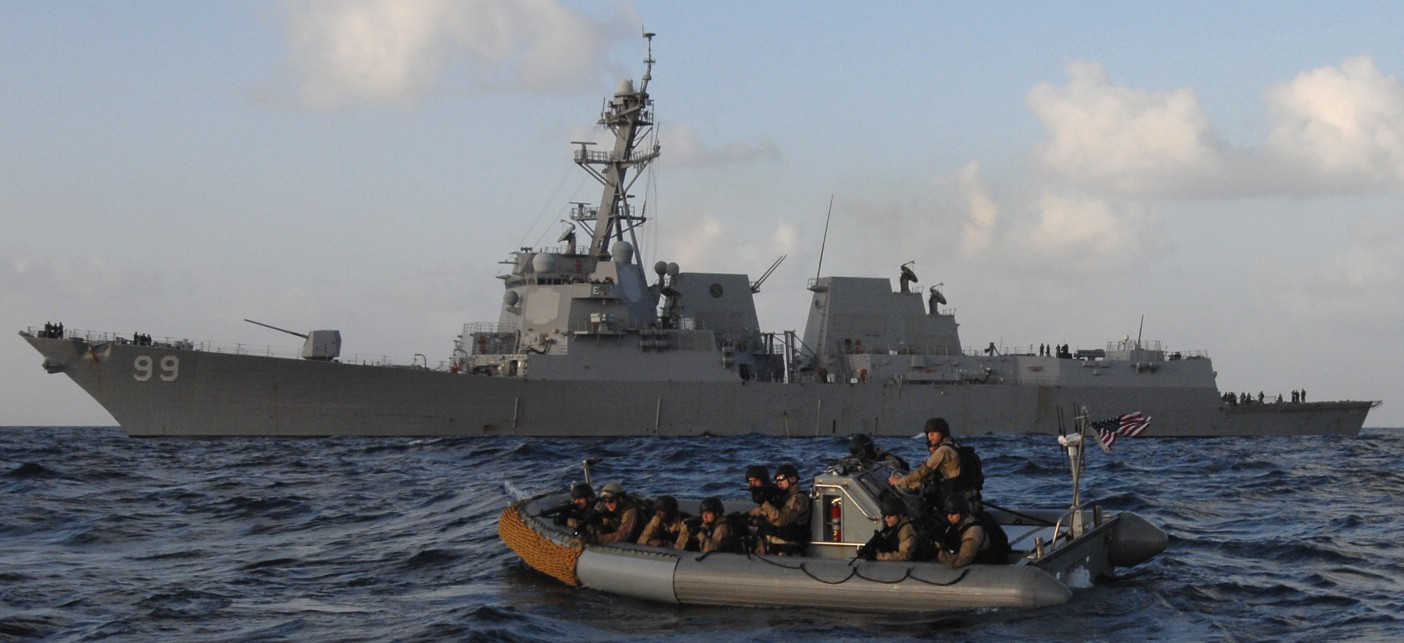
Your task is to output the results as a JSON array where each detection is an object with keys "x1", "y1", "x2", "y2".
[{"x1": 498, "y1": 418, "x2": 1167, "y2": 612}]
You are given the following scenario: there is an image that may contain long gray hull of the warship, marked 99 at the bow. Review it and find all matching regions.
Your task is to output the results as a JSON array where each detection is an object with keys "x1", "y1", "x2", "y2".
[{"x1": 22, "y1": 333, "x2": 1373, "y2": 437}]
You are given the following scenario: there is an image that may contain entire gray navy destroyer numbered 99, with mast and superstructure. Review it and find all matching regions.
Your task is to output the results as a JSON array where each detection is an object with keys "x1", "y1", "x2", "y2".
[{"x1": 20, "y1": 37, "x2": 1379, "y2": 437}]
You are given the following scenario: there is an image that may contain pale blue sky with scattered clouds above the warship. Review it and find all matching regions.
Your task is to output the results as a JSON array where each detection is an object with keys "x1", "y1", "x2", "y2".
[{"x1": 0, "y1": 0, "x2": 1404, "y2": 427}]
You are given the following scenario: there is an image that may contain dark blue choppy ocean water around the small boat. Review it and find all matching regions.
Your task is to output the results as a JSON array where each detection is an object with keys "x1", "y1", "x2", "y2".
[{"x1": 0, "y1": 428, "x2": 1404, "y2": 642}]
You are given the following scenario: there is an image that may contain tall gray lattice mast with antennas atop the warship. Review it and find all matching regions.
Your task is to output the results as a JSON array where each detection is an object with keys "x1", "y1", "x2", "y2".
[{"x1": 571, "y1": 32, "x2": 658, "y2": 258}]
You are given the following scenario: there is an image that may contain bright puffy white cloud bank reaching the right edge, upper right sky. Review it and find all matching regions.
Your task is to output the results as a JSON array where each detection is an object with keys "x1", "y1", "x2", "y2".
[{"x1": 1026, "y1": 56, "x2": 1404, "y2": 199}]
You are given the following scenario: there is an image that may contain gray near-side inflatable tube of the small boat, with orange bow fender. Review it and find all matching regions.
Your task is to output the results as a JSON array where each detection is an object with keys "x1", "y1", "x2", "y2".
[{"x1": 498, "y1": 497, "x2": 1072, "y2": 612}]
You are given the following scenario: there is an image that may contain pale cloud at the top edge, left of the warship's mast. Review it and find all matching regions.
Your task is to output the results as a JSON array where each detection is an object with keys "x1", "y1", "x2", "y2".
[{"x1": 285, "y1": 0, "x2": 623, "y2": 110}]
